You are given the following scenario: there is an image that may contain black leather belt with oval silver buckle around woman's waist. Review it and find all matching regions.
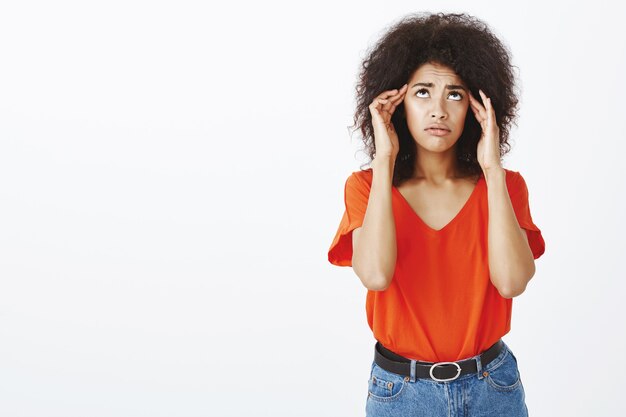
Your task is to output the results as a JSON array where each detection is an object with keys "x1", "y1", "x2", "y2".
[{"x1": 374, "y1": 339, "x2": 503, "y2": 382}]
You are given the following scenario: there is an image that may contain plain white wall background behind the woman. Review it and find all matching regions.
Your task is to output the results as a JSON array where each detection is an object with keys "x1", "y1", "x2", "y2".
[{"x1": 0, "y1": 1, "x2": 626, "y2": 417}]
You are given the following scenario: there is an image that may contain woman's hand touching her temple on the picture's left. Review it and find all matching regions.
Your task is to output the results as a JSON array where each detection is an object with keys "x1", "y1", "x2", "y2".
[{"x1": 369, "y1": 84, "x2": 407, "y2": 161}]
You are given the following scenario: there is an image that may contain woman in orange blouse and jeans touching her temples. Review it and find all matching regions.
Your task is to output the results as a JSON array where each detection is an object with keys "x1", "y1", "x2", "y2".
[{"x1": 328, "y1": 13, "x2": 545, "y2": 417}]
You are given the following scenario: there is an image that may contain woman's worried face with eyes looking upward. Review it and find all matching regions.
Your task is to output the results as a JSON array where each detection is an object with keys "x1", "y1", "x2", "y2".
[{"x1": 404, "y1": 63, "x2": 469, "y2": 152}]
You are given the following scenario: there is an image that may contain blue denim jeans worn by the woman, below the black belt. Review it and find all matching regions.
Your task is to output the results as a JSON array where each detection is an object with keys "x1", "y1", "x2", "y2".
[{"x1": 365, "y1": 341, "x2": 528, "y2": 417}]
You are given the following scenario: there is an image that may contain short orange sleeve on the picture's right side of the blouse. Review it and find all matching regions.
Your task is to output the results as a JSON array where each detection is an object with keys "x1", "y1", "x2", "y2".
[{"x1": 509, "y1": 171, "x2": 546, "y2": 259}]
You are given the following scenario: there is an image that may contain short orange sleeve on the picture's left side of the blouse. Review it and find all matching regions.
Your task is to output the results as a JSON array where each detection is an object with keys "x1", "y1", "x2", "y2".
[{"x1": 328, "y1": 172, "x2": 370, "y2": 266}]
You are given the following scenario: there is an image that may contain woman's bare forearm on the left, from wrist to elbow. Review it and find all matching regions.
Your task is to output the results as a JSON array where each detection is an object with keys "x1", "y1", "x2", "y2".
[{"x1": 352, "y1": 157, "x2": 397, "y2": 291}]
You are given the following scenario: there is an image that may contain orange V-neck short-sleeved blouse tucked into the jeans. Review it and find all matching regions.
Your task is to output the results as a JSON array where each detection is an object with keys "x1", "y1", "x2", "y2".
[{"x1": 328, "y1": 168, "x2": 545, "y2": 362}]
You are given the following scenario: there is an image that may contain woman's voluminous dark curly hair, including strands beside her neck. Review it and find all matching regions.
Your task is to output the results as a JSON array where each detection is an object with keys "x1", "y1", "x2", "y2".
[{"x1": 351, "y1": 13, "x2": 518, "y2": 185}]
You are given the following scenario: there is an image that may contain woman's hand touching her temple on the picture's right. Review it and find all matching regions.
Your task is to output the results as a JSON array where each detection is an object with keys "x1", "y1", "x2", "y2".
[{"x1": 469, "y1": 90, "x2": 502, "y2": 174}]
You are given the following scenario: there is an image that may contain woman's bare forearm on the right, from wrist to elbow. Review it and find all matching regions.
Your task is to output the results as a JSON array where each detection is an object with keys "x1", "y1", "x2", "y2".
[{"x1": 485, "y1": 169, "x2": 535, "y2": 298}]
